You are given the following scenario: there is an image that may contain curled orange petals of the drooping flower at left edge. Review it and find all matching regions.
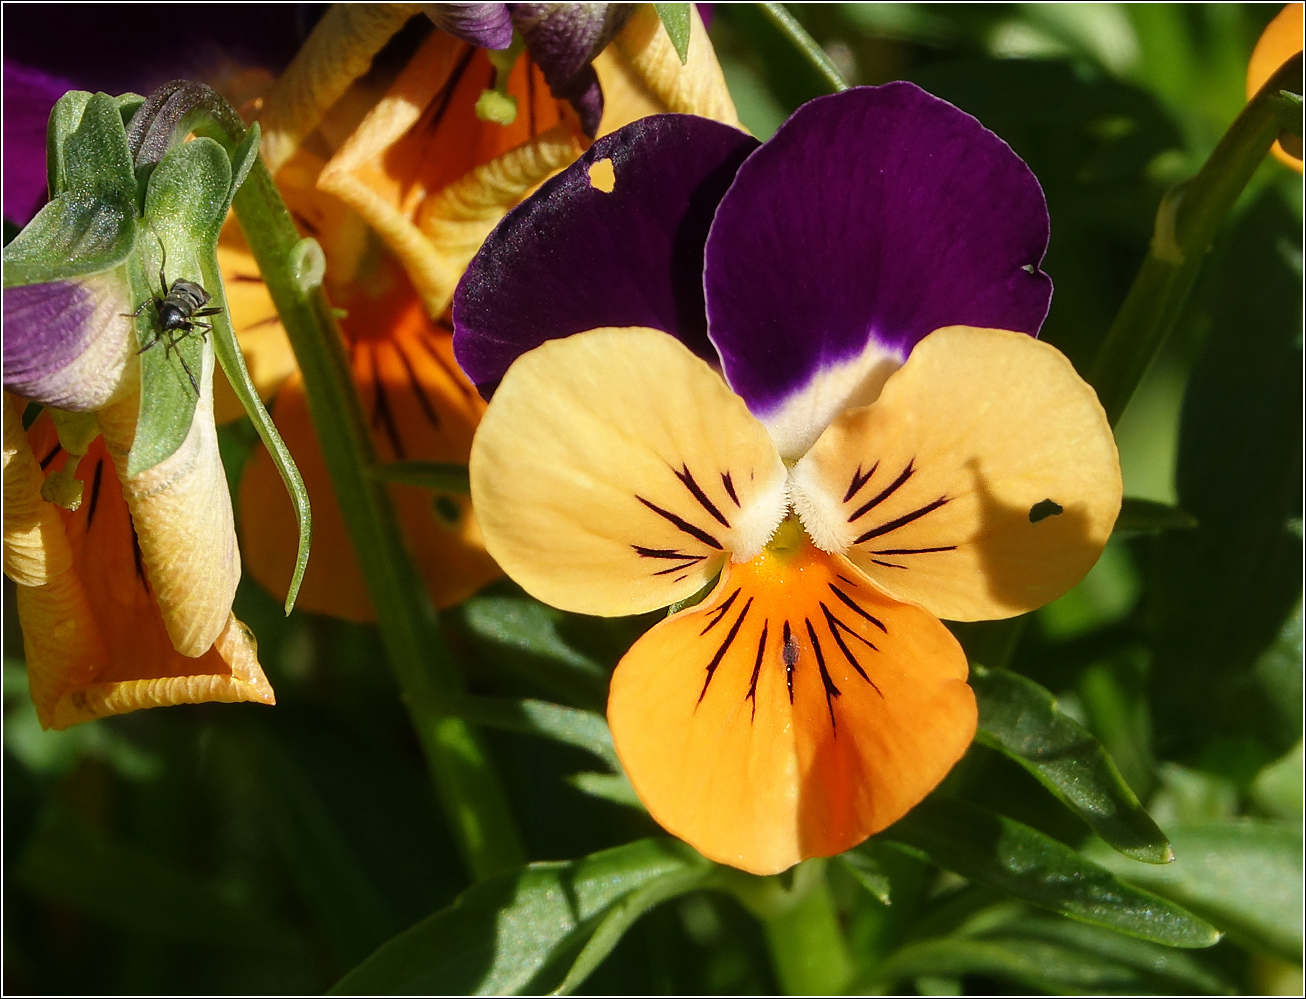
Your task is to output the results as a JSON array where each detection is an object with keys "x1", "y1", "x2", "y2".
[{"x1": 4, "y1": 393, "x2": 274, "y2": 729}]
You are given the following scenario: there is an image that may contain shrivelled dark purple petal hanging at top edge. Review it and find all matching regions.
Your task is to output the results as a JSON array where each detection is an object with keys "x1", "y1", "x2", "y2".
[{"x1": 512, "y1": 4, "x2": 635, "y2": 136}]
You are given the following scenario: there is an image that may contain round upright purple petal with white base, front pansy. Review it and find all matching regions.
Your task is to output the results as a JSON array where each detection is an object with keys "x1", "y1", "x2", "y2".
[{"x1": 704, "y1": 82, "x2": 1051, "y2": 428}]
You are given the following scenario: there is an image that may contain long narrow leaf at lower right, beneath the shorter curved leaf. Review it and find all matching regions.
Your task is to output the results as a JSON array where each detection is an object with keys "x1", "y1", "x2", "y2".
[{"x1": 883, "y1": 798, "x2": 1220, "y2": 947}]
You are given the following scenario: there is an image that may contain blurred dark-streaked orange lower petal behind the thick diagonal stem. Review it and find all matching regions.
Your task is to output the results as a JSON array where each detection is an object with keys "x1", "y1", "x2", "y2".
[{"x1": 240, "y1": 304, "x2": 500, "y2": 622}]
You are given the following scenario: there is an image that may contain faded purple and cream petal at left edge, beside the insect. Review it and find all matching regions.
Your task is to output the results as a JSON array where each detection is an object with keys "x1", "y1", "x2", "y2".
[{"x1": 3, "y1": 269, "x2": 136, "y2": 413}]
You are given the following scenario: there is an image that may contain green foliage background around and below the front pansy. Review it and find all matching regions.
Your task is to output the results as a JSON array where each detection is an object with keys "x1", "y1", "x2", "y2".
[{"x1": 4, "y1": 4, "x2": 1302, "y2": 995}]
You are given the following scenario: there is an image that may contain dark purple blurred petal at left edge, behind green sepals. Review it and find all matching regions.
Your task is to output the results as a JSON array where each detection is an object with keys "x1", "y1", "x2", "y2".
[{"x1": 4, "y1": 59, "x2": 74, "y2": 226}]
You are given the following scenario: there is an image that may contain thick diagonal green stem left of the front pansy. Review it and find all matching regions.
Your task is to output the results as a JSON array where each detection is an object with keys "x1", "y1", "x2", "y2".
[{"x1": 235, "y1": 159, "x2": 525, "y2": 880}]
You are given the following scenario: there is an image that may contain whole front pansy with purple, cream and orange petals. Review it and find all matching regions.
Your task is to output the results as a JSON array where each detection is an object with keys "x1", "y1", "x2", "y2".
[{"x1": 453, "y1": 84, "x2": 1121, "y2": 874}]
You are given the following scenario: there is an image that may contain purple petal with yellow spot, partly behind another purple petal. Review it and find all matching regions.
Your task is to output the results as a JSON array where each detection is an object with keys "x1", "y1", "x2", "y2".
[{"x1": 453, "y1": 115, "x2": 757, "y2": 398}]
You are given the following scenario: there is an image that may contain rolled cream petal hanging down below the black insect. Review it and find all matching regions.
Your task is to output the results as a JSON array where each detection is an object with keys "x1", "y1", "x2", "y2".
[{"x1": 99, "y1": 349, "x2": 240, "y2": 657}]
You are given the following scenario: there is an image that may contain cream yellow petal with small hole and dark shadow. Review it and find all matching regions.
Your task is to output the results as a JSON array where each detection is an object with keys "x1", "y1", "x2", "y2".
[{"x1": 790, "y1": 326, "x2": 1122, "y2": 620}]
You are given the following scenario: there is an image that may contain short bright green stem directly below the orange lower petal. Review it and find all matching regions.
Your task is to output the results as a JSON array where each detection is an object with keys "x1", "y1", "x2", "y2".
[{"x1": 764, "y1": 859, "x2": 853, "y2": 995}]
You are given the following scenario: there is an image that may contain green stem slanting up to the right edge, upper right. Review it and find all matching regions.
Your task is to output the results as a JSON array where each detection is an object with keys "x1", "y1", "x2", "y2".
[{"x1": 1088, "y1": 55, "x2": 1302, "y2": 426}]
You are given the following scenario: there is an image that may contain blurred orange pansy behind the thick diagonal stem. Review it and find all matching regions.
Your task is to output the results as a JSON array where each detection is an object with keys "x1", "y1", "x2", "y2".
[{"x1": 229, "y1": 4, "x2": 738, "y2": 620}]
